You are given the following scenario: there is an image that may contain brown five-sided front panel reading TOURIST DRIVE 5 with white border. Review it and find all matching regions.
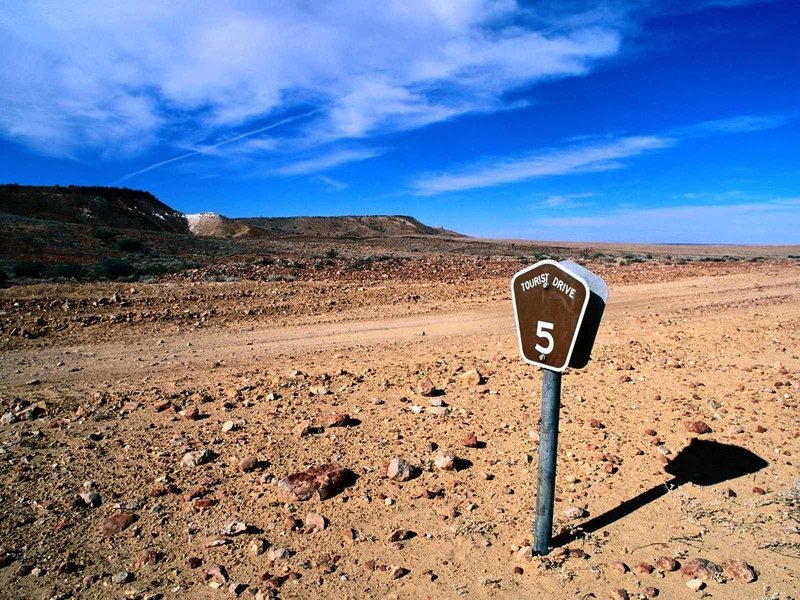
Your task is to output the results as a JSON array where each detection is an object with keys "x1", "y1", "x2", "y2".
[{"x1": 511, "y1": 260, "x2": 590, "y2": 371}]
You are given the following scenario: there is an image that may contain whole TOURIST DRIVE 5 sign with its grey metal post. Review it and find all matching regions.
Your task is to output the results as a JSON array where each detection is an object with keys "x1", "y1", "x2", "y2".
[{"x1": 511, "y1": 260, "x2": 608, "y2": 555}]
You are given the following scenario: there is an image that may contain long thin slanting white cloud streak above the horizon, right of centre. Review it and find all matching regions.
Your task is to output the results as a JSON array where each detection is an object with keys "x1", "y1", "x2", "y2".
[{"x1": 411, "y1": 136, "x2": 674, "y2": 195}]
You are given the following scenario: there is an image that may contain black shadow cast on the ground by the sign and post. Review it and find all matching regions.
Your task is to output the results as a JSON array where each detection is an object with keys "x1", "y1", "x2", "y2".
[{"x1": 552, "y1": 438, "x2": 768, "y2": 547}]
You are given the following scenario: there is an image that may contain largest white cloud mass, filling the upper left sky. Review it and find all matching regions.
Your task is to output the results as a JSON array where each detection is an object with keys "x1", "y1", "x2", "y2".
[{"x1": 0, "y1": 0, "x2": 620, "y2": 156}]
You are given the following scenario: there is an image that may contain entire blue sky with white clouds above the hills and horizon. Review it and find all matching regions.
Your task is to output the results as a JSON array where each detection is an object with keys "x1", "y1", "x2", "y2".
[{"x1": 0, "y1": 0, "x2": 800, "y2": 243}]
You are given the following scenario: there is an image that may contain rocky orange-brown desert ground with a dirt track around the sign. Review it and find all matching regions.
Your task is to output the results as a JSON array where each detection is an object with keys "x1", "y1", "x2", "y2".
[{"x1": 0, "y1": 254, "x2": 800, "y2": 600}]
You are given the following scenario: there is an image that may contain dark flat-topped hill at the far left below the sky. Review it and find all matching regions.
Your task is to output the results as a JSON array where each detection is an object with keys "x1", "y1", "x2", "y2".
[{"x1": 0, "y1": 184, "x2": 189, "y2": 233}]
